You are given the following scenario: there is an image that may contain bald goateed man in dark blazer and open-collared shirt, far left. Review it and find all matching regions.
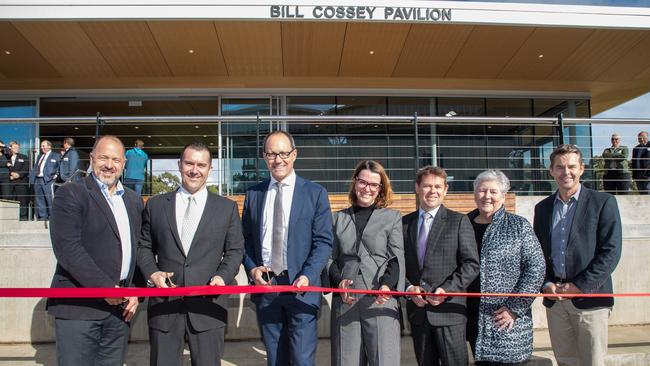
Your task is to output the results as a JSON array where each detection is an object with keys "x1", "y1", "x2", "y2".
[{"x1": 47, "y1": 136, "x2": 143, "y2": 366}]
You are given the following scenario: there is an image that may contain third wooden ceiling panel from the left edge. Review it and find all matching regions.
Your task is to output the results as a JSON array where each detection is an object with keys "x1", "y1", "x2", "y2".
[{"x1": 80, "y1": 22, "x2": 171, "y2": 76}]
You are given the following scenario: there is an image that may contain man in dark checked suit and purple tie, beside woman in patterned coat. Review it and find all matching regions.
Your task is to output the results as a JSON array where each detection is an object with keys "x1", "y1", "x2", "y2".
[{"x1": 402, "y1": 166, "x2": 479, "y2": 366}]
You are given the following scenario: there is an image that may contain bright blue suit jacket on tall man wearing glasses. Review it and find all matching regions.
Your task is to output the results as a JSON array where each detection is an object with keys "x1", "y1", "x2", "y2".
[{"x1": 242, "y1": 176, "x2": 332, "y2": 307}]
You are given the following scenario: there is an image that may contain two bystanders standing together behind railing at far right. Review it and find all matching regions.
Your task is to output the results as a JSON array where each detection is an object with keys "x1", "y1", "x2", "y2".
[{"x1": 602, "y1": 131, "x2": 650, "y2": 194}]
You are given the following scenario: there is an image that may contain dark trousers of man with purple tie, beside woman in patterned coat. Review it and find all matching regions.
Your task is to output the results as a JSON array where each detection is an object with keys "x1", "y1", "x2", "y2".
[{"x1": 411, "y1": 321, "x2": 469, "y2": 366}]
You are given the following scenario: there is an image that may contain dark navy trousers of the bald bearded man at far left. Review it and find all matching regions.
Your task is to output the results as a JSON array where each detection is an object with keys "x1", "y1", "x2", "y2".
[{"x1": 55, "y1": 311, "x2": 129, "y2": 366}]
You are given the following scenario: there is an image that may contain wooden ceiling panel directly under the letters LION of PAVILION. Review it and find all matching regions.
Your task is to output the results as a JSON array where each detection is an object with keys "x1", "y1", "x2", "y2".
[{"x1": 393, "y1": 24, "x2": 473, "y2": 78}]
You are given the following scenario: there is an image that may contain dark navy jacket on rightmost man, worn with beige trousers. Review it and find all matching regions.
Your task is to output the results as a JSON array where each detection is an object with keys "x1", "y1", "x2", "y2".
[{"x1": 533, "y1": 186, "x2": 623, "y2": 309}]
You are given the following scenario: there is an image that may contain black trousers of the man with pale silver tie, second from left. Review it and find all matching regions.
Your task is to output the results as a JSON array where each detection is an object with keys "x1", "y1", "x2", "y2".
[{"x1": 149, "y1": 313, "x2": 225, "y2": 366}]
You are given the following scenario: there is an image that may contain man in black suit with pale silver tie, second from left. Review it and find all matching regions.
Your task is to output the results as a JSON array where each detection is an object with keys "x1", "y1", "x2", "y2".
[{"x1": 138, "y1": 142, "x2": 244, "y2": 366}]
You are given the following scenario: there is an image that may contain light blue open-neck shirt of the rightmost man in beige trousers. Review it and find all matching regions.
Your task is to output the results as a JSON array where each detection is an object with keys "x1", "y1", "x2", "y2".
[{"x1": 551, "y1": 185, "x2": 582, "y2": 279}]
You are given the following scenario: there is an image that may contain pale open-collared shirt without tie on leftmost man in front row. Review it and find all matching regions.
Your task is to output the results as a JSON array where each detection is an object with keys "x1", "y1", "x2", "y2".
[{"x1": 93, "y1": 174, "x2": 132, "y2": 280}]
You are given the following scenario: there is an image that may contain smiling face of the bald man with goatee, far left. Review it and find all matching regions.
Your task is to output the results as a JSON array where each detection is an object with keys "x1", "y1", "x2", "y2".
[{"x1": 90, "y1": 138, "x2": 125, "y2": 188}]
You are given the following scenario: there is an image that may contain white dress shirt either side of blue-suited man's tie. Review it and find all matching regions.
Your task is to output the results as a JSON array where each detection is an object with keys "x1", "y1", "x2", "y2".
[{"x1": 262, "y1": 172, "x2": 296, "y2": 269}]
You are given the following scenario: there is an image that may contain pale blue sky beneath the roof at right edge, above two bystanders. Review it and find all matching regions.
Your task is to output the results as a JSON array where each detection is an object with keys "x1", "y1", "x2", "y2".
[{"x1": 592, "y1": 93, "x2": 650, "y2": 155}]
